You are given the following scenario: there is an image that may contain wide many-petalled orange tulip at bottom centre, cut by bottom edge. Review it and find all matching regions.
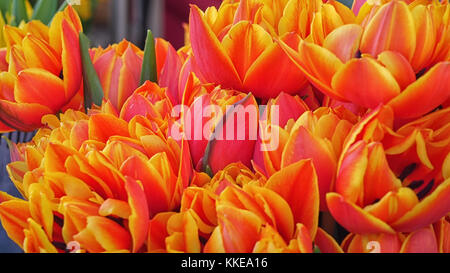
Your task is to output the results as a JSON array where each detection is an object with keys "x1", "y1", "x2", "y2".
[{"x1": 148, "y1": 160, "x2": 342, "y2": 253}]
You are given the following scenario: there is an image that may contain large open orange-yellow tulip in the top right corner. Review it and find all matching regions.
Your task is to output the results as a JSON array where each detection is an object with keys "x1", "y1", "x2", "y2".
[{"x1": 280, "y1": 0, "x2": 450, "y2": 119}]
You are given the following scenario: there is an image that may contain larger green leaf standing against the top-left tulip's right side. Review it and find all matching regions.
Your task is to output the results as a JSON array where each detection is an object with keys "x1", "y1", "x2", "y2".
[{"x1": 80, "y1": 32, "x2": 104, "y2": 110}]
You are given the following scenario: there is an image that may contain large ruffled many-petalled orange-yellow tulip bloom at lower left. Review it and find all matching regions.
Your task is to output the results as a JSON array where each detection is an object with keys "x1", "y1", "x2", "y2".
[{"x1": 0, "y1": 98, "x2": 192, "y2": 252}]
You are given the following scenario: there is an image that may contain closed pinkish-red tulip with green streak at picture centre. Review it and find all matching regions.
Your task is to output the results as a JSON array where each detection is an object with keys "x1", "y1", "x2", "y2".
[{"x1": 169, "y1": 88, "x2": 259, "y2": 173}]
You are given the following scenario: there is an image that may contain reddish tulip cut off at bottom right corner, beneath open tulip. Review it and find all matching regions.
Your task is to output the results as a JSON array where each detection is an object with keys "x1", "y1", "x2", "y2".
[{"x1": 342, "y1": 217, "x2": 450, "y2": 253}]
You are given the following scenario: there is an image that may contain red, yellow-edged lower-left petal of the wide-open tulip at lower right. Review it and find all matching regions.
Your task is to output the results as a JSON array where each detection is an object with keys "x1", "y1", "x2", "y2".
[{"x1": 327, "y1": 192, "x2": 395, "y2": 234}]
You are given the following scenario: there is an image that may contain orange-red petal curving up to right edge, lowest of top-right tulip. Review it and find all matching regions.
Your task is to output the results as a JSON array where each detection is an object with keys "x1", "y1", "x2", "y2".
[{"x1": 388, "y1": 62, "x2": 450, "y2": 118}]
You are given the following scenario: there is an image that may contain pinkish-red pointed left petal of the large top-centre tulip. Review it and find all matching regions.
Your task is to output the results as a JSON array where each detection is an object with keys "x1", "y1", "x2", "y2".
[{"x1": 189, "y1": 5, "x2": 242, "y2": 89}]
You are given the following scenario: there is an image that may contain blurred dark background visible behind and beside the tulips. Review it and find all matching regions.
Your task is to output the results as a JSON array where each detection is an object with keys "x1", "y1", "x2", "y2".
[{"x1": 0, "y1": 0, "x2": 353, "y2": 253}]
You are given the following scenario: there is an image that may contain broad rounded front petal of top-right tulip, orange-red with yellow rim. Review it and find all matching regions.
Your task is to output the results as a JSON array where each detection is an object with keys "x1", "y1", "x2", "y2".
[{"x1": 331, "y1": 58, "x2": 400, "y2": 108}]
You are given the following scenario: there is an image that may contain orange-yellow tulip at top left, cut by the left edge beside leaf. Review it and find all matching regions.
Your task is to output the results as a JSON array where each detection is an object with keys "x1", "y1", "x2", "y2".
[{"x1": 0, "y1": 6, "x2": 82, "y2": 131}]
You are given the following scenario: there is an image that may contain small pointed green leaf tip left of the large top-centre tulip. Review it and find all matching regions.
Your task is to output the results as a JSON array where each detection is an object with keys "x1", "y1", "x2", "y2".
[{"x1": 140, "y1": 30, "x2": 158, "y2": 84}]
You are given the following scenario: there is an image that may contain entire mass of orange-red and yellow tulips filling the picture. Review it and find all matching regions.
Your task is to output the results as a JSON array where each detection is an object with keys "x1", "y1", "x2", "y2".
[{"x1": 0, "y1": 0, "x2": 450, "y2": 253}]
